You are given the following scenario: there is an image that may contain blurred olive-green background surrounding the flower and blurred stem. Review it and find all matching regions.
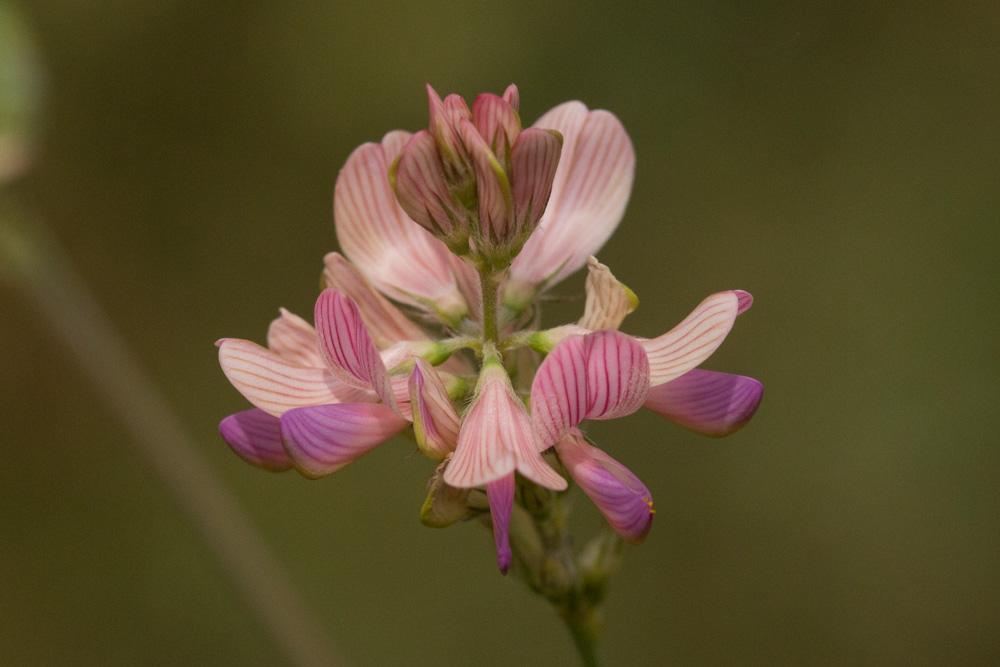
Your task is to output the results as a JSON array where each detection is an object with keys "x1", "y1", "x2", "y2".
[{"x1": 0, "y1": 0, "x2": 1000, "y2": 666}]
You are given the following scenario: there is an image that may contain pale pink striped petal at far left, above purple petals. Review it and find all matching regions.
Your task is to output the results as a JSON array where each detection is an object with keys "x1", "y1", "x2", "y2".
[{"x1": 216, "y1": 338, "x2": 374, "y2": 417}]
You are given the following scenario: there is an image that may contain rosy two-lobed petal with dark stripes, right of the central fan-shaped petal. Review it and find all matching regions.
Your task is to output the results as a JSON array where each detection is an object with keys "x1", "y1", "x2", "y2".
[{"x1": 531, "y1": 331, "x2": 649, "y2": 449}]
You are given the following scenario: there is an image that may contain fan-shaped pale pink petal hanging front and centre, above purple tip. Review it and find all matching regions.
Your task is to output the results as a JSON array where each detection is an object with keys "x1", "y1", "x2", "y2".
[{"x1": 444, "y1": 362, "x2": 566, "y2": 490}]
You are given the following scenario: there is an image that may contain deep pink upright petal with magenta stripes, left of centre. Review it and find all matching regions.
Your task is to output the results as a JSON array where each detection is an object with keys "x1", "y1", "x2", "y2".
[{"x1": 315, "y1": 289, "x2": 395, "y2": 406}]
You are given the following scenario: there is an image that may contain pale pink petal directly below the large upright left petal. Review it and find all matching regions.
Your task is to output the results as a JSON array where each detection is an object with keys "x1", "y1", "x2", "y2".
[{"x1": 322, "y1": 252, "x2": 427, "y2": 354}]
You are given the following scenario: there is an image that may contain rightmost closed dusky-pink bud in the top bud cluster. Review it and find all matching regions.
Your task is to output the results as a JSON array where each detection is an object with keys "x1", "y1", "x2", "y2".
[{"x1": 510, "y1": 128, "x2": 562, "y2": 243}]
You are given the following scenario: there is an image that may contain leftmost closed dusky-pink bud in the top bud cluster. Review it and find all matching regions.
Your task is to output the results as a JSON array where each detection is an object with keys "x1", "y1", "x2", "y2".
[{"x1": 393, "y1": 130, "x2": 469, "y2": 244}]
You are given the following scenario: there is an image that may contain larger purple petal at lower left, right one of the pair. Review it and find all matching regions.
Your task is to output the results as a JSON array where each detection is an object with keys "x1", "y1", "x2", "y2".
[{"x1": 281, "y1": 403, "x2": 407, "y2": 478}]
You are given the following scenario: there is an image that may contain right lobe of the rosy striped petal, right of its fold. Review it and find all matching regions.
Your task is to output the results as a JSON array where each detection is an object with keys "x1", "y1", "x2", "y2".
[{"x1": 583, "y1": 331, "x2": 649, "y2": 419}]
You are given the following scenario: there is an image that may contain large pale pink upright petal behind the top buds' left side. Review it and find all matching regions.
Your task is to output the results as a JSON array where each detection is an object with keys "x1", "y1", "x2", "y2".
[{"x1": 333, "y1": 131, "x2": 467, "y2": 321}]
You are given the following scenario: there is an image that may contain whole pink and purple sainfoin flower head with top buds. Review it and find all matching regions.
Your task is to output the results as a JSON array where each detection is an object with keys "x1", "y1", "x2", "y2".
[{"x1": 218, "y1": 86, "x2": 763, "y2": 584}]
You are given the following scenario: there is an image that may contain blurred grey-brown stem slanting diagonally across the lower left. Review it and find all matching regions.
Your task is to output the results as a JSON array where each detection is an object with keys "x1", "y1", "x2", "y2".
[{"x1": 0, "y1": 197, "x2": 345, "y2": 667}]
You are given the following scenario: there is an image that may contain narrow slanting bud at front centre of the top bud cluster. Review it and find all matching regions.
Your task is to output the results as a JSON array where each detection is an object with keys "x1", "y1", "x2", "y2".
[{"x1": 459, "y1": 121, "x2": 513, "y2": 247}]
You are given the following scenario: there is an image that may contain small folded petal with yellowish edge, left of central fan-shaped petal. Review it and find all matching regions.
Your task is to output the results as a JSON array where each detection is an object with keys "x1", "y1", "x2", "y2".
[{"x1": 408, "y1": 359, "x2": 459, "y2": 460}]
